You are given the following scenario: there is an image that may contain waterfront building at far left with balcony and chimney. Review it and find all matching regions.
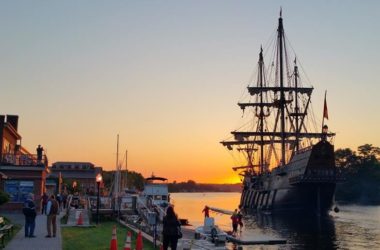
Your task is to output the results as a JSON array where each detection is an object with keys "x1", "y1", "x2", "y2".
[{"x1": 0, "y1": 115, "x2": 49, "y2": 210}]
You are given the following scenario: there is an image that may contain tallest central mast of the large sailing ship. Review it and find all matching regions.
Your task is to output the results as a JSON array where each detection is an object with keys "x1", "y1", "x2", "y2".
[{"x1": 277, "y1": 10, "x2": 285, "y2": 166}]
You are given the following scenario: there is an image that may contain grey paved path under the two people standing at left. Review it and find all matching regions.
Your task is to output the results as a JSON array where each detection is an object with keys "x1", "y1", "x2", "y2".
[{"x1": 5, "y1": 213, "x2": 63, "y2": 250}]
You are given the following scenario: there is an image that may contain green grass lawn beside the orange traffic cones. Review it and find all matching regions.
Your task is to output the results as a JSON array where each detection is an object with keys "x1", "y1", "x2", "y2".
[{"x1": 61, "y1": 221, "x2": 154, "y2": 250}]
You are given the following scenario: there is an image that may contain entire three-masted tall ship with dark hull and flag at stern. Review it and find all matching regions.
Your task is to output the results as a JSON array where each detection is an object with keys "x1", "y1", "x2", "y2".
[{"x1": 221, "y1": 12, "x2": 339, "y2": 215}]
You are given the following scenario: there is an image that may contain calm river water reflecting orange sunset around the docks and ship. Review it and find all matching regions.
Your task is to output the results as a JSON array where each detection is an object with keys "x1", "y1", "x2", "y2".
[{"x1": 171, "y1": 193, "x2": 380, "y2": 250}]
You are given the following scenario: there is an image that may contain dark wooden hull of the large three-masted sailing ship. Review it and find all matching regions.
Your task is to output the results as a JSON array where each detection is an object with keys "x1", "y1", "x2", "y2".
[{"x1": 240, "y1": 141, "x2": 338, "y2": 214}]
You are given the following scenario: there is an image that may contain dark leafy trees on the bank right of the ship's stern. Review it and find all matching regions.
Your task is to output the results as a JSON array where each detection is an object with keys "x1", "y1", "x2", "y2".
[{"x1": 335, "y1": 144, "x2": 380, "y2": 205}]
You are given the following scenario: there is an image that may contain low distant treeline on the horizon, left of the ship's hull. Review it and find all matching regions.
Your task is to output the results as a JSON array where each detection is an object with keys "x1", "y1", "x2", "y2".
[{"x1": 169, "y1": 180, "x2": 241, "y2": 193}]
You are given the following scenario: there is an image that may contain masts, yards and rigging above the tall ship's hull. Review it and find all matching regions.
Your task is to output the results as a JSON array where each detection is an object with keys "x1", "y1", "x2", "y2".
[{"x1": 221, "y1": 12, "x2": 335, "y2": 173}]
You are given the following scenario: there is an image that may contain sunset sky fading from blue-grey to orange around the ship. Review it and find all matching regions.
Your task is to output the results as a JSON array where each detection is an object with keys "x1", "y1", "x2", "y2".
[{"x1": 0, "y1": 0, "x2": 380, "y2": 183}]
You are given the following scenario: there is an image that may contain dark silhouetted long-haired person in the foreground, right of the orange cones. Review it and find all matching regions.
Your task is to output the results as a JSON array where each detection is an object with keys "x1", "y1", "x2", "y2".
[{"x1": 162, "y1": 206, "x2": 182, "y2": 250}]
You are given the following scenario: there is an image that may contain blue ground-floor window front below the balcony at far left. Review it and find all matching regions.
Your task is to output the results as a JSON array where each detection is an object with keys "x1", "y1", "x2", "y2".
[{"x1": 4, "y1": 180, "x2": 34, "y2": 202}]
